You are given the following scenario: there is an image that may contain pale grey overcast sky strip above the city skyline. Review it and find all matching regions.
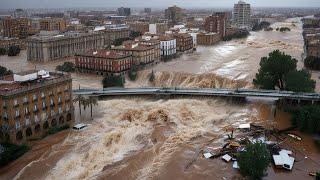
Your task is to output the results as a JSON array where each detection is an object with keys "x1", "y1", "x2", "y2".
[{"x1": 0, "y1": 0, "x2": 320, "y2": 9}]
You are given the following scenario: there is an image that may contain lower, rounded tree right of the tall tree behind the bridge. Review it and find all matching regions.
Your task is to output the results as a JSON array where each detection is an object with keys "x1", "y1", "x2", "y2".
[{"x1": 285, "y1": 70, "x2": 316, "y2": 92}]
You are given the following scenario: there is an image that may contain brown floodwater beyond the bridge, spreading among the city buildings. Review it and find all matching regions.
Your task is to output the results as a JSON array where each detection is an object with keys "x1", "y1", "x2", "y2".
[{"x1": 0, "y1": 18, "x2": 310, "y2": 88}]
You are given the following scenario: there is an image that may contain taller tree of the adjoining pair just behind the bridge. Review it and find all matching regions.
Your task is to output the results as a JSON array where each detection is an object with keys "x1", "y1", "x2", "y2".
[{"x1": 253, "y1": 50, "x2": 297, "y2": 90}]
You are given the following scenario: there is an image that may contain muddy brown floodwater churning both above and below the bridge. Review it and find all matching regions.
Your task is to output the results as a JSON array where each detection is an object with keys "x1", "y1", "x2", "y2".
[{"x1": 0, "y1": 19, "x2": 320, "y2": 180}]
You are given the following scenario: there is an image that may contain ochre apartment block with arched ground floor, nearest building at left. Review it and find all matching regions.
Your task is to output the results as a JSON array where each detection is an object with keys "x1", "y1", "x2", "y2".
[{"x1": 0, "y1": 70, "x2": 74, "y2": 144}]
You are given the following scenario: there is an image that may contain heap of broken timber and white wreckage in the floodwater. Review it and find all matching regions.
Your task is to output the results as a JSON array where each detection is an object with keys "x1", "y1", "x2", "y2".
[{"x1": 202, "y1": 124, "x2": 302, "y2": 171}]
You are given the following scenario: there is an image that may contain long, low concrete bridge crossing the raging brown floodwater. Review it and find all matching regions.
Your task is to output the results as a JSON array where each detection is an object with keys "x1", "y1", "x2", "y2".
[{"x1": 73, "y1": 87, "x2": 320, "y2": 104}]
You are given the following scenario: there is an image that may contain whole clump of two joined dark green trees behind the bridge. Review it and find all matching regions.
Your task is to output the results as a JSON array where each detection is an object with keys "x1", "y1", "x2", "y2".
[{"x1": 253, "y1": 50, "x2": 315, "y2": 92}]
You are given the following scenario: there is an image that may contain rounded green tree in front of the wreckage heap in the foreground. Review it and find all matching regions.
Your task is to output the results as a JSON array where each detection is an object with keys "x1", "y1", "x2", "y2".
[{"x1": 238, "y1": 142, "x2": 270, "y2": 180}]
